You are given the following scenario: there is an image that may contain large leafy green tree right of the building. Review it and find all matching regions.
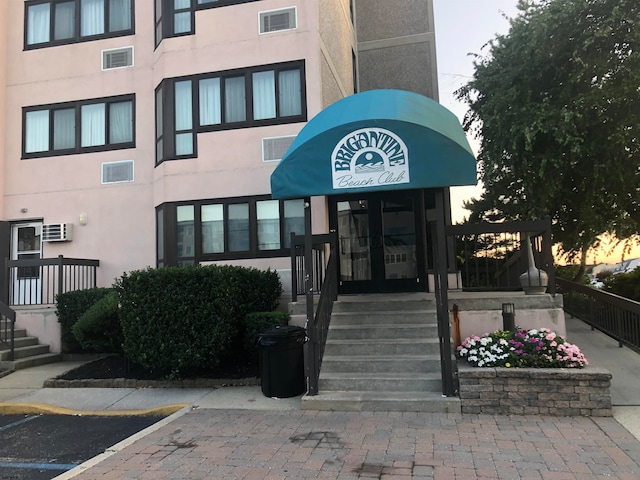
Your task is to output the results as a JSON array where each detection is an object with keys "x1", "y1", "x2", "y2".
[{"x1": 457, "y1": 0, "x2": 640, "y2": 276}]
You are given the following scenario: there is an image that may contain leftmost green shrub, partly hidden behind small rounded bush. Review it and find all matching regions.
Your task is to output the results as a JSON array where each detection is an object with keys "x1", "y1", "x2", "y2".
[{"x1": 56, "y1": 288, "x2": 113, "y2": 353}]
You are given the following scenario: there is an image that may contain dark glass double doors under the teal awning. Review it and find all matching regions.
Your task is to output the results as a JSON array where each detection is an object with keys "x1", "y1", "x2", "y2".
[{"x1": 329, "y1": 192, "x2": 422, "y2": 293}]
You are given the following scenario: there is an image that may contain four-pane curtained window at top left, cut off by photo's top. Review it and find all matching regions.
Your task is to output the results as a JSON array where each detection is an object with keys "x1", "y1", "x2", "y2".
[{"x1": 25, "y1": 0, "x2": 134, "y2": 49}]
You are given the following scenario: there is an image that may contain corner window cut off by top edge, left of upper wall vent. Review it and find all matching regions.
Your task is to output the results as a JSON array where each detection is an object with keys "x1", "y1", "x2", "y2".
[{"x1": 155, "y1": 0, "x2": 258, "y2": 47}]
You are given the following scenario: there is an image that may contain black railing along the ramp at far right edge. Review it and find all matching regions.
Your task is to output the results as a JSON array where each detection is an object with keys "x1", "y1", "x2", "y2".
[{"x1": 556, "y1": 278, "x2": 640, "y2": 352}]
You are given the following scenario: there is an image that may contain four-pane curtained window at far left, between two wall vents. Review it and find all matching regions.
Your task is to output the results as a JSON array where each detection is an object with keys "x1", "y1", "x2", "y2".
[{"x1": 22, "y1": 95, "x2": 135, "y2": 158}]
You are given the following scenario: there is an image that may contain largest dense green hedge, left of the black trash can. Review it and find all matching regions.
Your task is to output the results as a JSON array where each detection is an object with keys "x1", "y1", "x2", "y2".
[{"x1": 115, "y1": 265, "x2": 282, "y2": 377}]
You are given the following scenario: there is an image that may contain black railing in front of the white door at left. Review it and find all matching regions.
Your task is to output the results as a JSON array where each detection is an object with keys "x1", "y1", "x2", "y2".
[{"x1": 5, "y1": 255, "x2": 100, "y2": 305}]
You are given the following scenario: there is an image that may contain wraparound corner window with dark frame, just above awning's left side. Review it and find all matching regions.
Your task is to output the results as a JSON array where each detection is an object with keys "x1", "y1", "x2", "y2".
[{"x1": 156, "y1": 61, "x2": 306, "y2": 164}]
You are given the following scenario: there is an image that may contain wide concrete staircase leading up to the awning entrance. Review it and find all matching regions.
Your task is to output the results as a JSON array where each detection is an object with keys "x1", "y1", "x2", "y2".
[{"x1": 302, "y1": 293, "x2": 460, "y2": 413}]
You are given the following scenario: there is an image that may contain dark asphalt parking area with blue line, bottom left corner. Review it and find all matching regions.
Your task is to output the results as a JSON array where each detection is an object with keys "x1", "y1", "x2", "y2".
[{"x1": 0, "y1": 415, "x2": 164, "y2": 480}]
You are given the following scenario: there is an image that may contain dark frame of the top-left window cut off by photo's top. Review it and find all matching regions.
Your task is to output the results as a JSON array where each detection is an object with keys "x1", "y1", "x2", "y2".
[{"x1": 23, "y1": 0, "x2": 136, "y2": 50}]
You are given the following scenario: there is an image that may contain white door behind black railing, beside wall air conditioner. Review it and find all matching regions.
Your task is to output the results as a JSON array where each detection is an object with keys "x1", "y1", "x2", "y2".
[{"x1": 11, "y1": 222, "x2": 42, "y2": 305}]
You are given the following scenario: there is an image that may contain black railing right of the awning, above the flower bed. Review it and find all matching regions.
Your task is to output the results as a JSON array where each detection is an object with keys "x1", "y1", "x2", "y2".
[{"x1": 445, "y1": 218, "x2": 555, "y2": 294}]
